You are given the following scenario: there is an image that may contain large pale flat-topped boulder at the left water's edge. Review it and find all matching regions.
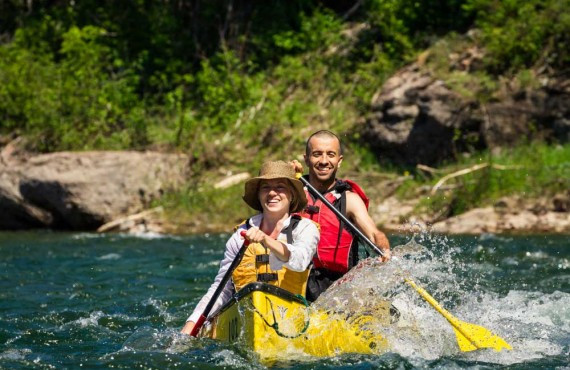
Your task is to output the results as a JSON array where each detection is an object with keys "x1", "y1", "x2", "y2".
[{"x1": 0, "y1": 152, "x2": 188, "y2": 230}]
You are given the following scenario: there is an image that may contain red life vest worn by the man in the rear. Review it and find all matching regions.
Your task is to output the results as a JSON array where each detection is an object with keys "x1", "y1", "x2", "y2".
[{"x1": 300, "y1": 180, "x2": 369, "y2": 274}]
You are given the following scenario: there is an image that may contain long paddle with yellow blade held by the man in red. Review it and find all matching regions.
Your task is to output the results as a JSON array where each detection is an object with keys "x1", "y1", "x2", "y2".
[{"x1": 299, "y1": 177, "x2": 513, "y2": 352}]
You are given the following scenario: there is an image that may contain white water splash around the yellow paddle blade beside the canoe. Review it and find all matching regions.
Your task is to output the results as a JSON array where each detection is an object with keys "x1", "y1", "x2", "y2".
[{"x1": 314, "y1": 231, "x2": 570, "y2": 364}]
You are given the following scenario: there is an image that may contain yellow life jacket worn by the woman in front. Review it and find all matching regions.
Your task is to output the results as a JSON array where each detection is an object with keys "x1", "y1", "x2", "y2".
[{"x1": 232, "y1": 215, "x2": 311, "y2": 297}]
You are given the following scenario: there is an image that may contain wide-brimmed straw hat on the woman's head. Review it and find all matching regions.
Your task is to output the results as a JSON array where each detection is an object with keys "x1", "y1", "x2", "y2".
[{"x1": 243, "y1": 161, "x2": 307, "y2": 213}]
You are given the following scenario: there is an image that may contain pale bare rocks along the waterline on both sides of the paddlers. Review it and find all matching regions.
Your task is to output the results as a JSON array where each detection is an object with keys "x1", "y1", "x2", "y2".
[{"x1": 0, "y1": 148, "x2": 570, "y2": 234}]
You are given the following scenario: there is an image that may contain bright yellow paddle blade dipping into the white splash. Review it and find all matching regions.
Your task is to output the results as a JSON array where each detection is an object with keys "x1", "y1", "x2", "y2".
[{"x1": 451, "y1": 320, "x2": 513, "y2": 352}]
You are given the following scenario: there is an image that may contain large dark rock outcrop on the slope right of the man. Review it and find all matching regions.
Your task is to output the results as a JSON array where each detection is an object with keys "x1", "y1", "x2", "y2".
[{"x1": 361, "y1": 63, "x2": 570, "y2": 165}]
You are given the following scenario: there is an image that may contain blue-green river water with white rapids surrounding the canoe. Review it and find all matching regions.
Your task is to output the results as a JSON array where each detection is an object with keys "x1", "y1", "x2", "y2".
[{"x1": 0, "y1": 232, "x2": 570, "y2": 369}]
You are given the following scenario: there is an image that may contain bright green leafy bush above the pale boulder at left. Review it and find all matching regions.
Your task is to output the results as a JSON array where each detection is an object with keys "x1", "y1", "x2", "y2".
[{"x1": 0, "y1": 26, "x2": 143, "y2": 151}]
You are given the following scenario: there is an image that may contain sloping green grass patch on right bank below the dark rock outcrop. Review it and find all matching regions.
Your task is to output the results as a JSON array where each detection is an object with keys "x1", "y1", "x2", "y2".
[{"x1": 397, "y1": 142, "x2": 570, "y2": 217}]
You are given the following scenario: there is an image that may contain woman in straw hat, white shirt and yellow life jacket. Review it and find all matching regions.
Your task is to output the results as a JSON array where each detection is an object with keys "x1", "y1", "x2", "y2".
[{"x1": 182, "y1": 161, "x2": 319, "y2": 334}]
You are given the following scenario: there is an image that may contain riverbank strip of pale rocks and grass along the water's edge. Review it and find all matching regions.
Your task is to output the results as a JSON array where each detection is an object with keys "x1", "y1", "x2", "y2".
[{"x1": 0, "y1": 145, "x2": 570, "y2": 234}]
